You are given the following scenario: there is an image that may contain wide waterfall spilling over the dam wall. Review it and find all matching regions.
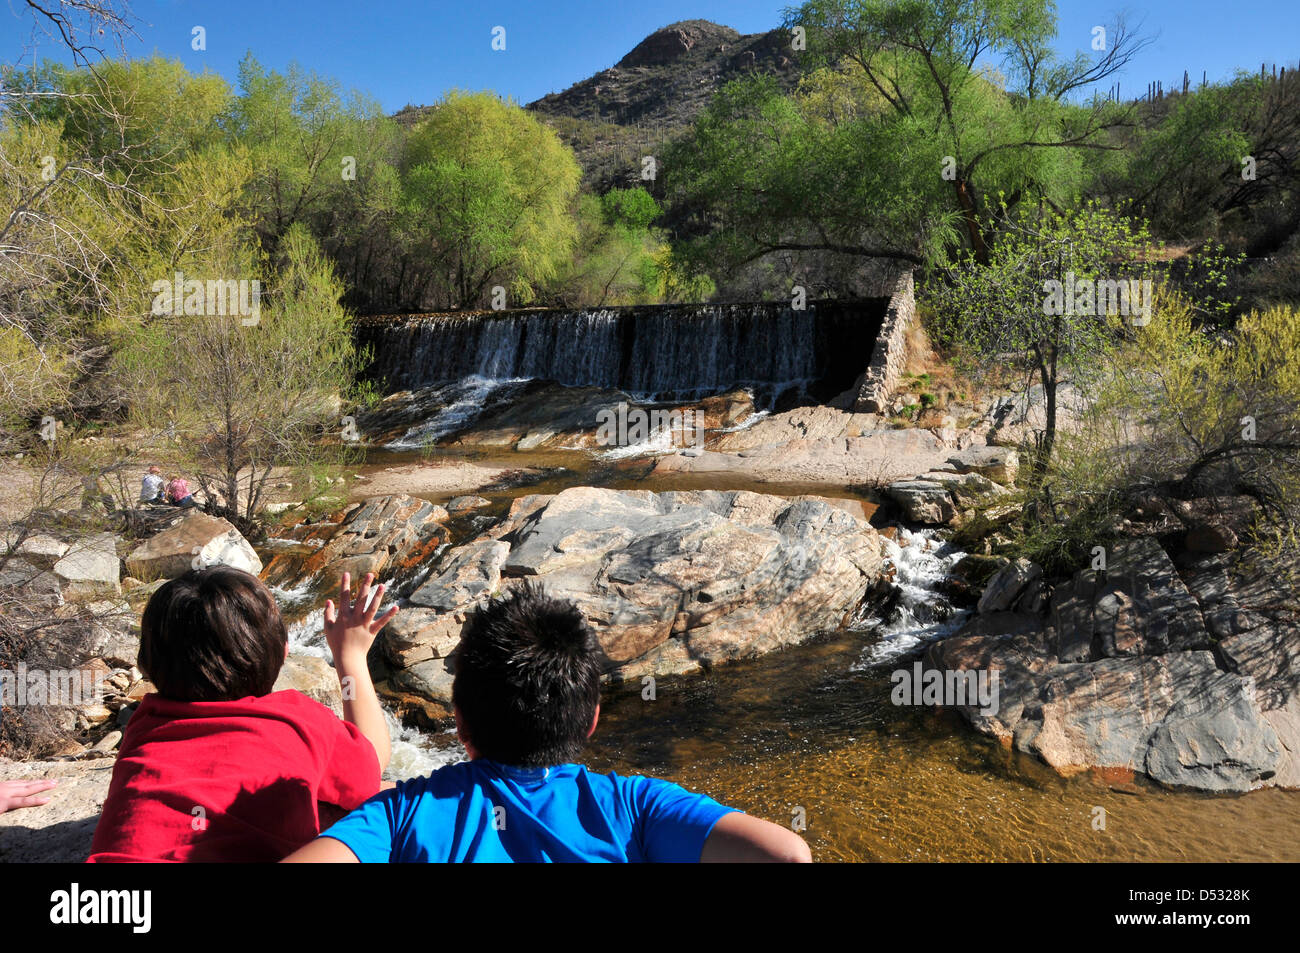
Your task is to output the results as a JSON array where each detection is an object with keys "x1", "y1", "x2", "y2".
[{"x1": 358, "y1": 298, "x2": 887, "y2": 400}]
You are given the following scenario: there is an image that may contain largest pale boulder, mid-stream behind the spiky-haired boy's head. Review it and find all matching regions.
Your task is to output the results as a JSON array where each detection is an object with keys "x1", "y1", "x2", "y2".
[{"x1": 381, "y1": 486, "x2": 881, "y2": 701}]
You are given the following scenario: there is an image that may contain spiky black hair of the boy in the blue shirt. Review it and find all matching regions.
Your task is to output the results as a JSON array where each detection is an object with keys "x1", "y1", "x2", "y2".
[{"x1": 451, "y1": 582, "x2": 601, "y2": 767}]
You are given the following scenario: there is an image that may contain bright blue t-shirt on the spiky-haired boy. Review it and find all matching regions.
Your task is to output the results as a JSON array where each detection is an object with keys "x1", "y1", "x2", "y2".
[{"x1": 321, "y1": 758, "x2": 735, "y2": 863}]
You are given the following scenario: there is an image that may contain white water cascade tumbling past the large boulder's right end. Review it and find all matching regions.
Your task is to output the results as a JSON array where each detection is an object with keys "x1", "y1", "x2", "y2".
[{"x1": 850, "y1": 528, "x2": 970, "y2": 672}]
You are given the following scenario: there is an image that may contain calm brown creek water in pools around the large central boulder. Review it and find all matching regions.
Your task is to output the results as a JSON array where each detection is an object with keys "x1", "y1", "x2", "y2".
[{"x1": 325, "y1": 452, "x2": 1300, "y2": 862}]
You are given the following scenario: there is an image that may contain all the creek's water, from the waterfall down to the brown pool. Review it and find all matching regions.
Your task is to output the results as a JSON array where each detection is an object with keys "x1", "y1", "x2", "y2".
[{"x1": 292, "y1": 299, "x2": 1300, "y2": 861}]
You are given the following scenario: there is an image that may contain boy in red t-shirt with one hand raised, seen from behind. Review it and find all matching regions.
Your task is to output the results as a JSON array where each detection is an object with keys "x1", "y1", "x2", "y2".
[{"x1": 90, "y1": 566, "x2": 397, "y2": 863}]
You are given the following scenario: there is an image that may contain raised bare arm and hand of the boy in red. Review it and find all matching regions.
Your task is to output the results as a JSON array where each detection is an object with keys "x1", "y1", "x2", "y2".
[{"x1": 325, "y1": 572, "x2": 398, "y2": 771}]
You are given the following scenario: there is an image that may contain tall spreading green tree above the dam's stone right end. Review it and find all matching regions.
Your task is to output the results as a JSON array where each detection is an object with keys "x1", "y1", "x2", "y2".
[{"x1": 664, "y1": 0, "x2": 1143, "y2": 278}]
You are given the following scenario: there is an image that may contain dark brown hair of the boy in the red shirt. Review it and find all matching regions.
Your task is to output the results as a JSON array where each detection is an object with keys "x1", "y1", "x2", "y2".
[{"x1": 138, "y1": 566, "x2": 289, "y2": 702}]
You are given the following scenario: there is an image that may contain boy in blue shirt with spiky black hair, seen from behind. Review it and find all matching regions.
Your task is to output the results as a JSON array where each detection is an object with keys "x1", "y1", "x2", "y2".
[{"x1": 285, "y1": 584, "x2": 811, "y2": 863}]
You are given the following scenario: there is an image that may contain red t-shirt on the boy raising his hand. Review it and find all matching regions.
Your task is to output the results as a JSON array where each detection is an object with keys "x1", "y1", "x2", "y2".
[{"x1": 90, "y1": 690, "x2": 380, "y2": 863}]
